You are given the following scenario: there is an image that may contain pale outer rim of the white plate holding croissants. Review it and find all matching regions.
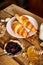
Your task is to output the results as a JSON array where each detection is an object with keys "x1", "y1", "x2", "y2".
[{"x1": 6, "y1": 15, "x2": 38, "y2": 38}]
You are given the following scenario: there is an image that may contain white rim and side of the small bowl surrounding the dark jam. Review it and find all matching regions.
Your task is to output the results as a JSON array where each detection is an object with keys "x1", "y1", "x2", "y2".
[{"x1": 4, "y1": 40, "x2": 24, "y2": 57}]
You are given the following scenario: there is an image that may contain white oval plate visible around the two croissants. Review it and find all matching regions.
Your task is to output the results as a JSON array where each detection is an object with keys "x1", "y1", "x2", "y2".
[{"x1": 6, "y1": 15, "x2": 38, "y2": 38}]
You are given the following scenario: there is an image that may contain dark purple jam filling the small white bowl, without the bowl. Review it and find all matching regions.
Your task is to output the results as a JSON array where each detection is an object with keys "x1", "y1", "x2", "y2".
[{"x1": 5, "y1": 41, "x2": 22, "y2": 55}]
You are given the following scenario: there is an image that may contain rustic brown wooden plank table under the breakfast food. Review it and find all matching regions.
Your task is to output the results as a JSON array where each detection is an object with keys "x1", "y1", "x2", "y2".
[{"x1": 0, "y1": 4, "x2": 43, "y2": 65}]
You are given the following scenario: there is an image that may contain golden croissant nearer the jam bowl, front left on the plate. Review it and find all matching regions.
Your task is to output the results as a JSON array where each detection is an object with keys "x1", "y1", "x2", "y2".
[{"x1": 12, "y1": 21, "x2": 29, "y2": 38}]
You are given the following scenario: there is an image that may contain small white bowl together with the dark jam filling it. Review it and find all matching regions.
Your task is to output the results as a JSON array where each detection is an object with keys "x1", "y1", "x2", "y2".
[{"x1": 4, "y1": 40, "x2": 23, "y2": 56}]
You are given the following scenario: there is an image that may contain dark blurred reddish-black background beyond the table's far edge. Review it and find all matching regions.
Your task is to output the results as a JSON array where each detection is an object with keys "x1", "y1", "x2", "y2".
[{"x1": 0, "y1": 0, "x2": 43, "y2": 18}]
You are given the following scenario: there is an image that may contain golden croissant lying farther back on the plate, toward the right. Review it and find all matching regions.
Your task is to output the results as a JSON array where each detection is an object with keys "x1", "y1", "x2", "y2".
[{"x1": 15, "y1": 14, "x2": 37, "y2": 32}]
